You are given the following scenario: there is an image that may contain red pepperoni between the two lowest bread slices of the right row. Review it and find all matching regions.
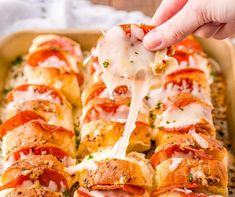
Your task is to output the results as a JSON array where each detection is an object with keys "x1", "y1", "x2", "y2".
[{"x1": 151, "y1": 144, "x2": 213, "y2": 168}]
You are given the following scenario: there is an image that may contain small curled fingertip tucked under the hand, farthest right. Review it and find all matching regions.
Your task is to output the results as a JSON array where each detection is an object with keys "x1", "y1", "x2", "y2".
[{"x1": 194, "y1": 22, "x2": 224, "y2": 38}]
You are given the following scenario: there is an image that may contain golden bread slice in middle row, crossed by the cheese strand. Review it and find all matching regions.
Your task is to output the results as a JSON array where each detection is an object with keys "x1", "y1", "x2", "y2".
[{"x1": 79, "y1": 120, "x2": 151, "y2": 157}]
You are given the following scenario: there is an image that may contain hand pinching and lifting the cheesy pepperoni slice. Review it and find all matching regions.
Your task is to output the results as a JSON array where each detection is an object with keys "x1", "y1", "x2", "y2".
[{"x1": 144, "y1": 0, "x2": 235, "y2": 50}]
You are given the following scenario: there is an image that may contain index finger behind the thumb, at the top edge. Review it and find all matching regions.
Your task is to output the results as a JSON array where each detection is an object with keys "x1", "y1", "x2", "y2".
[{"x1": 150, "y1": 0, "x2": 188, "y2": 26}]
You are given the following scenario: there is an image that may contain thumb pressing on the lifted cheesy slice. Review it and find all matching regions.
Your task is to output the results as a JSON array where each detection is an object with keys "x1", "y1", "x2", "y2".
[{"x1": 144, "y1": 1, "x2": 204, "y2": 51}]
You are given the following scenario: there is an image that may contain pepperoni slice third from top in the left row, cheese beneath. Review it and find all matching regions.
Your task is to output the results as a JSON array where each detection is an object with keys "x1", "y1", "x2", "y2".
[{"x1": 7, "y1": 84, "x2": 63, "y2": 104}]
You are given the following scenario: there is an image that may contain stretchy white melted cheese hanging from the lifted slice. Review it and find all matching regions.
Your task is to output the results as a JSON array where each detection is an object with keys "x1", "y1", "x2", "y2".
[{"x1": 97, "y1": 25, "x2": 155, "y2": 159}]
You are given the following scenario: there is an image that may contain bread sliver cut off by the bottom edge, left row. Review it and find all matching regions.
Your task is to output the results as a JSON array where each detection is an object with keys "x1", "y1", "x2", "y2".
[{"x1": 6, "y1": 188, "x2": 63, "y2": 197}]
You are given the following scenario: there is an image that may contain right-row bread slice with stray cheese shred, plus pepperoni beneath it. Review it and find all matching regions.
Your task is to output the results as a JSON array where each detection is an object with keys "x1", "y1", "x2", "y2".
[{"x1": 151, "y1": 132, "x2": 228, "y2": 167}]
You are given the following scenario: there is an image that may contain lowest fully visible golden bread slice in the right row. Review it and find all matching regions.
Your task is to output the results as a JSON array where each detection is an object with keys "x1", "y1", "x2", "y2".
[{"x1": 155, "y1": 159, "x2": 228, "y2": 195}]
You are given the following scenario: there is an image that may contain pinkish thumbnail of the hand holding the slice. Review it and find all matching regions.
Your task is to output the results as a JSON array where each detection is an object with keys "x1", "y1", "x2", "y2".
[{"x1": 144, "y1": 32, "x2": 162, "y2": 51}]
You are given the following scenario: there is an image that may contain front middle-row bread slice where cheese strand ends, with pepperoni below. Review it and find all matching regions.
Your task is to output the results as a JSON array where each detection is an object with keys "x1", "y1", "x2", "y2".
[{"x1": 67, "y1": 149, "x2": 153, "y2": 195}]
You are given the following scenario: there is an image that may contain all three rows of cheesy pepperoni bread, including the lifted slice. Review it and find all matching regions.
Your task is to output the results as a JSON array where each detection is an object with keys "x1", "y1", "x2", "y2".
[{"x1": 0, "y1": 24, "x2": 234, "y2": 197}]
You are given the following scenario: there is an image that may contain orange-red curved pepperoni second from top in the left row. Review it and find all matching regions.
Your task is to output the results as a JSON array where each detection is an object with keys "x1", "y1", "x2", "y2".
[{"x1": 27, "y1": 47, "x2": 69, "y2": 67}]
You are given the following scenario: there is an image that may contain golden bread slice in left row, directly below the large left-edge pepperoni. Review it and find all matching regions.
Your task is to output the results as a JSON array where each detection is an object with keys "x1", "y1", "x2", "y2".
[{"x1": 3, "y1": 121, "x2": 75, "y2": 158}]
